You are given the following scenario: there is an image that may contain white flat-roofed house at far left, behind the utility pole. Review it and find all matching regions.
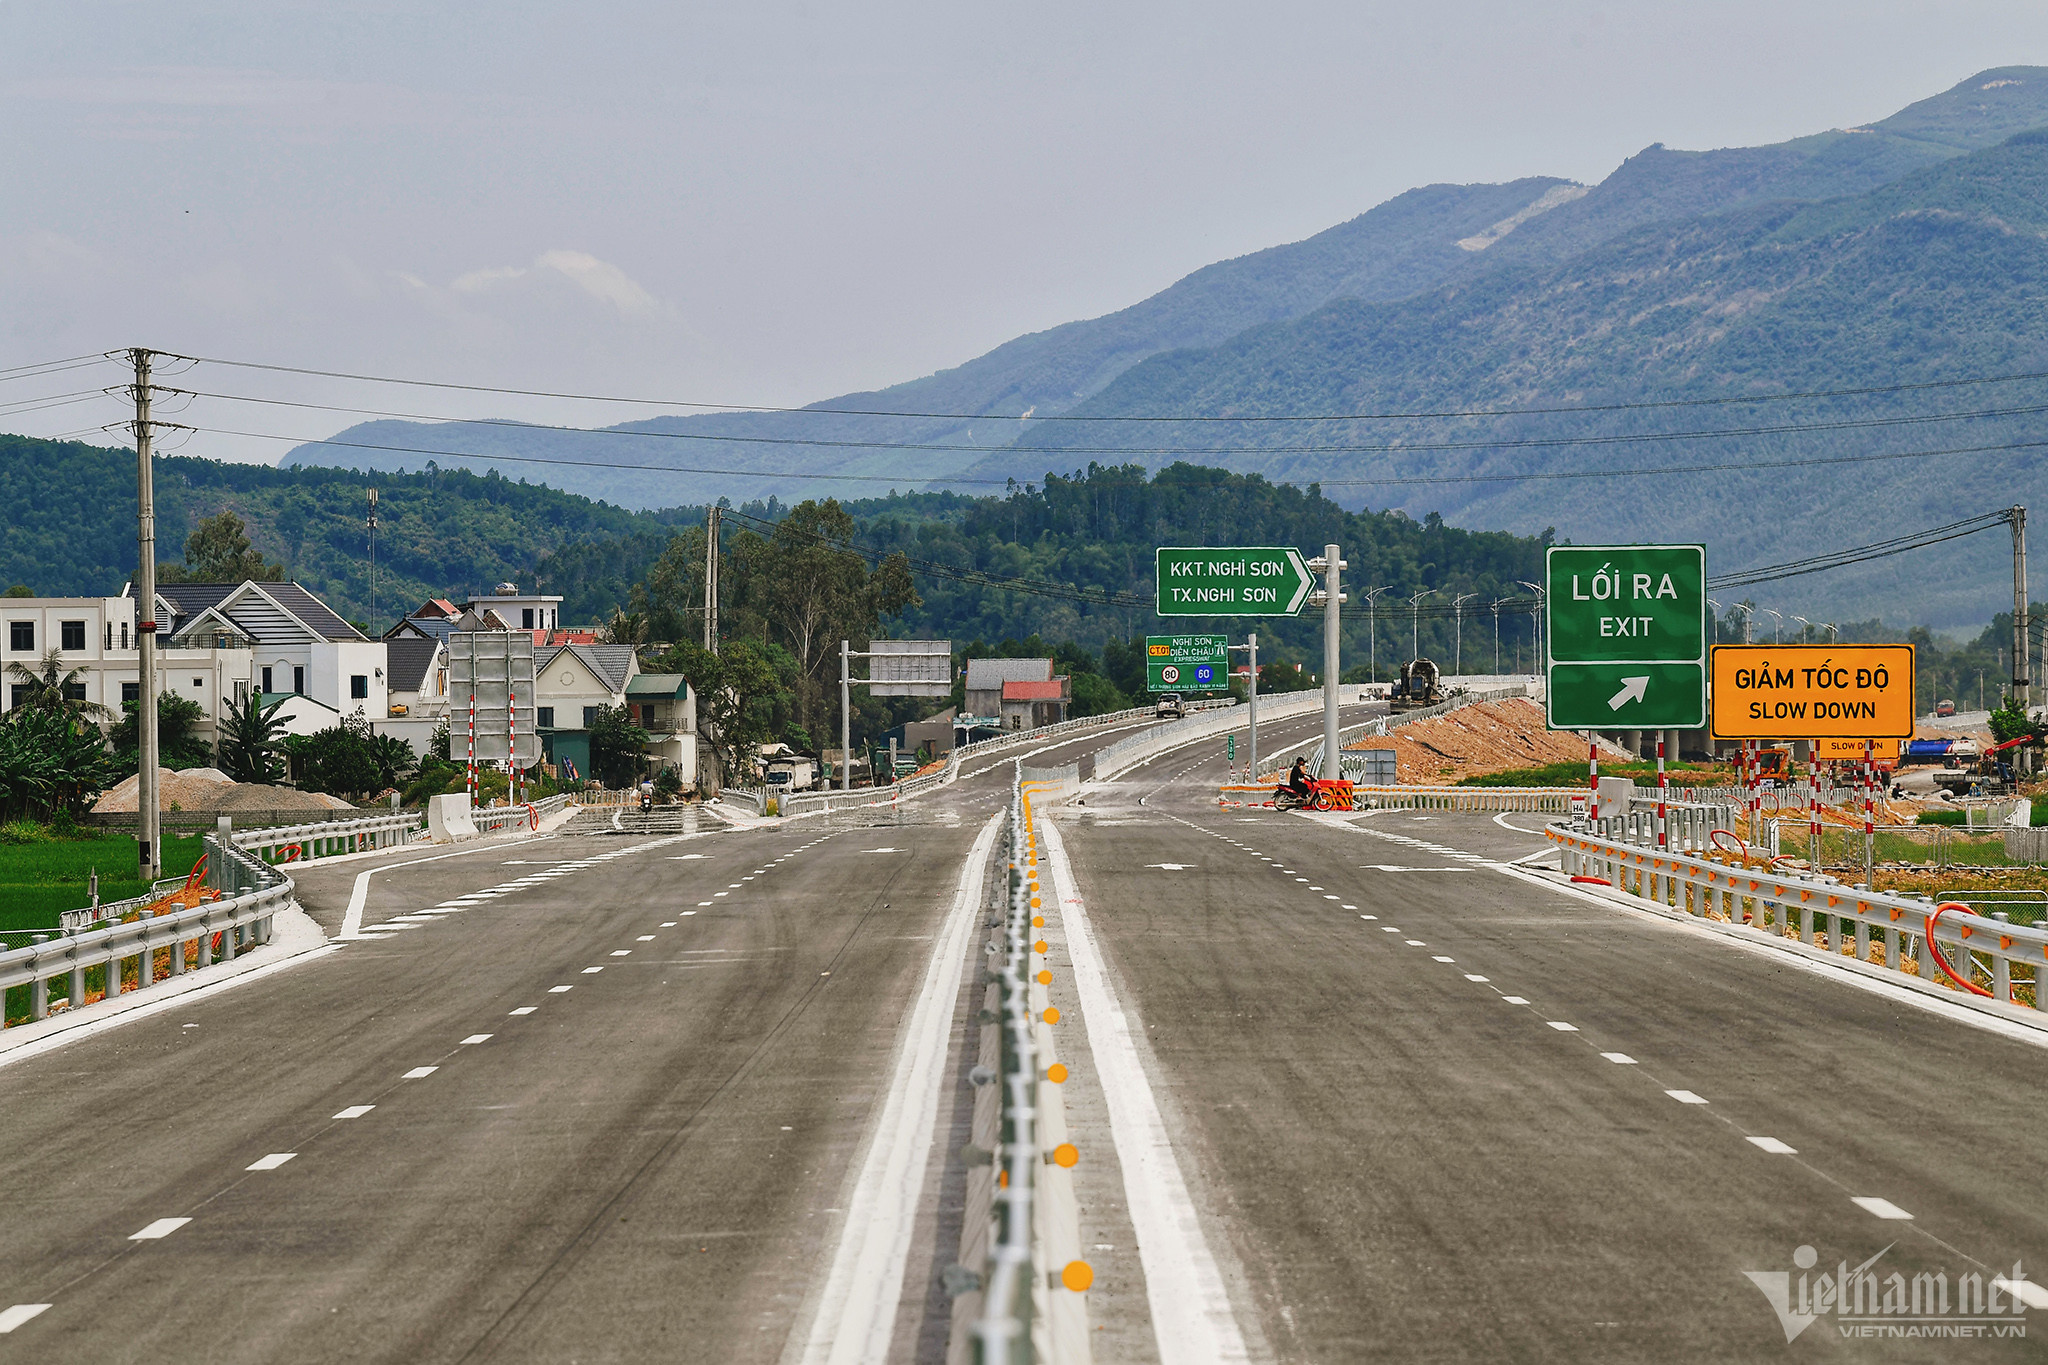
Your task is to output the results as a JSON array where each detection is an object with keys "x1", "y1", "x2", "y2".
[{"x1": 0, "y1": 593, "x2": 254, "y2": 743}]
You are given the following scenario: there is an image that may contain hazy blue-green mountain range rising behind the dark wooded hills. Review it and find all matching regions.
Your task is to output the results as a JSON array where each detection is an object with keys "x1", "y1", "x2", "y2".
[{"x1": 287, "y1": 68, "x2": 2048, "y2": 626}]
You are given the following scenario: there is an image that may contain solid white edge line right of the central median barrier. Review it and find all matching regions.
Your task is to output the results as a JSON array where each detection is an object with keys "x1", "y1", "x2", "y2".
[{"x1": 1040, "y1": 821, "x2": 1251, "y2": 1365}]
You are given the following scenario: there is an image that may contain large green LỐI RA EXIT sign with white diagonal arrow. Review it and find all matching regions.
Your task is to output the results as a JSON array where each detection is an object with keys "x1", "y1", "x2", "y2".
[{"x1": 1544, "y1": 544, "x2": 1708, "y2": 731}]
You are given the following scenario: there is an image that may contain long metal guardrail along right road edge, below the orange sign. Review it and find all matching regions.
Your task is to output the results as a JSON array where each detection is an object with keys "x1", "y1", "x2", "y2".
[{"x1": 1544, "y1": 819, "x2": 2048, "y2": 1011}]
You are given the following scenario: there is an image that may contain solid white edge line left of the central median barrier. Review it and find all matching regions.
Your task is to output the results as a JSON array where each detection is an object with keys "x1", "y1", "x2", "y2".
[{"x1": 784, "y1": 812, "x2": 1004, "y2": 1365}]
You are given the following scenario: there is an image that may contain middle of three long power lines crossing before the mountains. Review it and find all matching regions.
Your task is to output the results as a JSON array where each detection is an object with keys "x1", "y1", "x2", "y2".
[{"x1": 166, "y1": 389, "x2": 2048, "y2": 456}]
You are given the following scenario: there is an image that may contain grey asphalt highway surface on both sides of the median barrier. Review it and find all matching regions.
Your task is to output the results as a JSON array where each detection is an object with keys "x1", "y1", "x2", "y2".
[{"x1": 0, "y1": 699, "x2": 2048, "y2": 1365}]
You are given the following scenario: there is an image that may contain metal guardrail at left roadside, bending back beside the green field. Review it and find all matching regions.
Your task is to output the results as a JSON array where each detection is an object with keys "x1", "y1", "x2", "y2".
[{"x1": 0, "y1": 835, "x2": 293, "y2": 1023}]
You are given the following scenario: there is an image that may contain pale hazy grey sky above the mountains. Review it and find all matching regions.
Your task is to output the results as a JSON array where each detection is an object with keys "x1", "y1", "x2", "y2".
[{"x1": 0, "y1": 0, "x2": 2048, "y2": 458}]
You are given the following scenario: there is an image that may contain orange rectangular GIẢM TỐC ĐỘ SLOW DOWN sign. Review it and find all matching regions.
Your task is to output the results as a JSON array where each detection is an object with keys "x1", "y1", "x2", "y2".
[{"x1": 1710, "y1": 645, "x2": 1913, "y2": 740}]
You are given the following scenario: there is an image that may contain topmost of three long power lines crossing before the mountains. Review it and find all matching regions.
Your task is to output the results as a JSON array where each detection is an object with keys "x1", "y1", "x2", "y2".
[{"x1": 159, "y1": 352, "x2": 2048, "y2": 422}]
